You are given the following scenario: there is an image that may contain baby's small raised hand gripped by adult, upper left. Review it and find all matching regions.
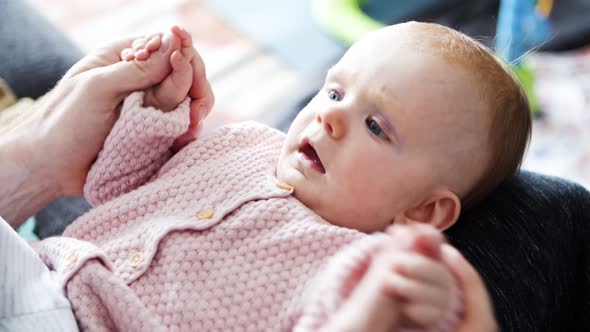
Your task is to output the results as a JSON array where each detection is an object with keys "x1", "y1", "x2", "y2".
[{"x1": 121, "y1": 26, "x2": 195, "y2": 111}]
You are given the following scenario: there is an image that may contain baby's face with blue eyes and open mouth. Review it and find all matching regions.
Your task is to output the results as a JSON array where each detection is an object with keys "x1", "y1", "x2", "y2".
[{"x1": 277, "y1": 24, "x2": 485, "y2": 232}]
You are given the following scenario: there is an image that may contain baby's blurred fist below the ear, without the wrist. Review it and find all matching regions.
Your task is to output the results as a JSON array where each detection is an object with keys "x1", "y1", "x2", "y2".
[{"x1": 380, "y1": 225, "x2": 455, "y2": 328}]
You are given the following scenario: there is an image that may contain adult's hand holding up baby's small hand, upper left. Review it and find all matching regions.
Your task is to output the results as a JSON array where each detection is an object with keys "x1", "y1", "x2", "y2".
[{"x1": 29, "y1": 28, "x2": 214, "y2": 196}]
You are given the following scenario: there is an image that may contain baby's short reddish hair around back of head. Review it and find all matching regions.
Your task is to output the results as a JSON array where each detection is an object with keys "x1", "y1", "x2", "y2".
[{"x1": 407, "y1": 22, "x2": 532, "y2": 209}]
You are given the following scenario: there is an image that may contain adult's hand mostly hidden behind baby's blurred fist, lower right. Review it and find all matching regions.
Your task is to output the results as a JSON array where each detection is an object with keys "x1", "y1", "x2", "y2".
[{"x1": 442, "y1": 244, "x2": 499, "y2": 332}]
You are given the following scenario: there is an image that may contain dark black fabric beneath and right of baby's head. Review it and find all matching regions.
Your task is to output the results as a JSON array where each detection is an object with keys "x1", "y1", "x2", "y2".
[{"x1": 446, "y1": 171, "x2": 590, "y2": 331}]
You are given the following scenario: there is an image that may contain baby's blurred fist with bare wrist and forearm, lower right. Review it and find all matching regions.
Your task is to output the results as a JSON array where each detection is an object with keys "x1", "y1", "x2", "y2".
[{"x1": 336, "y1": 225, "x2": 454, "y2": 332}]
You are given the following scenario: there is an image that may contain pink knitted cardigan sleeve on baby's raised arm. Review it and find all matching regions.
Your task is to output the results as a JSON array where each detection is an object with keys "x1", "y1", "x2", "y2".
[{"x1": 84, "y1": 92, "x2": 190, "y2": 206}]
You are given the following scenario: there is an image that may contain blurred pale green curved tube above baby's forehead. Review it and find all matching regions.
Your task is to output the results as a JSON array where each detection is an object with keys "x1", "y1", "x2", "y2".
[{"x1": 313, "y1": 0, "x2": 385, "y2": 46}]
